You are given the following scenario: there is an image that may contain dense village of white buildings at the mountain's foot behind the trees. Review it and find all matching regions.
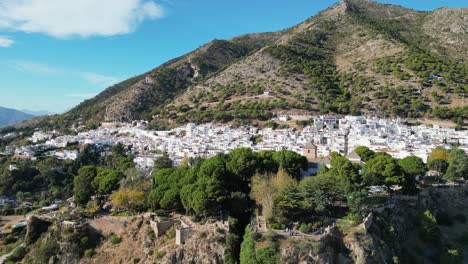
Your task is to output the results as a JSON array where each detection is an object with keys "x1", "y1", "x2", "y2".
[{"x1": 4, "y1": 116, "x2": 468, "y2": 175}]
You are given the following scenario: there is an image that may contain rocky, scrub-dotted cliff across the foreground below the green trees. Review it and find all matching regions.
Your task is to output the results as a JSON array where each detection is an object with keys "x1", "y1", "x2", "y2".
[{"x1": 9, "y1": 186, "x2": 468, "y2": 264}]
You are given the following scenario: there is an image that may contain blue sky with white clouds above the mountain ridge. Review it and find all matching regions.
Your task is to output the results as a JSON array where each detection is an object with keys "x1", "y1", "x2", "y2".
[{"x1": 0, "y1": 0, "x2": 468, "y2": 113}]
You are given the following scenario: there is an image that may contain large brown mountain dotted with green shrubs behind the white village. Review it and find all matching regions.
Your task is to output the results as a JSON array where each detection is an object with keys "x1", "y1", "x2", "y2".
[{"x1": 49, "y1": 0, "x2": 468, "y2": 128}]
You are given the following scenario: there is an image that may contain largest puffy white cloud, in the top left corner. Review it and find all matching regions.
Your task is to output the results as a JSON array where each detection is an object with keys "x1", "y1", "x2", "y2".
[{"x1": 0, "y1": 0, "x2": 164, "y2": 38}]
